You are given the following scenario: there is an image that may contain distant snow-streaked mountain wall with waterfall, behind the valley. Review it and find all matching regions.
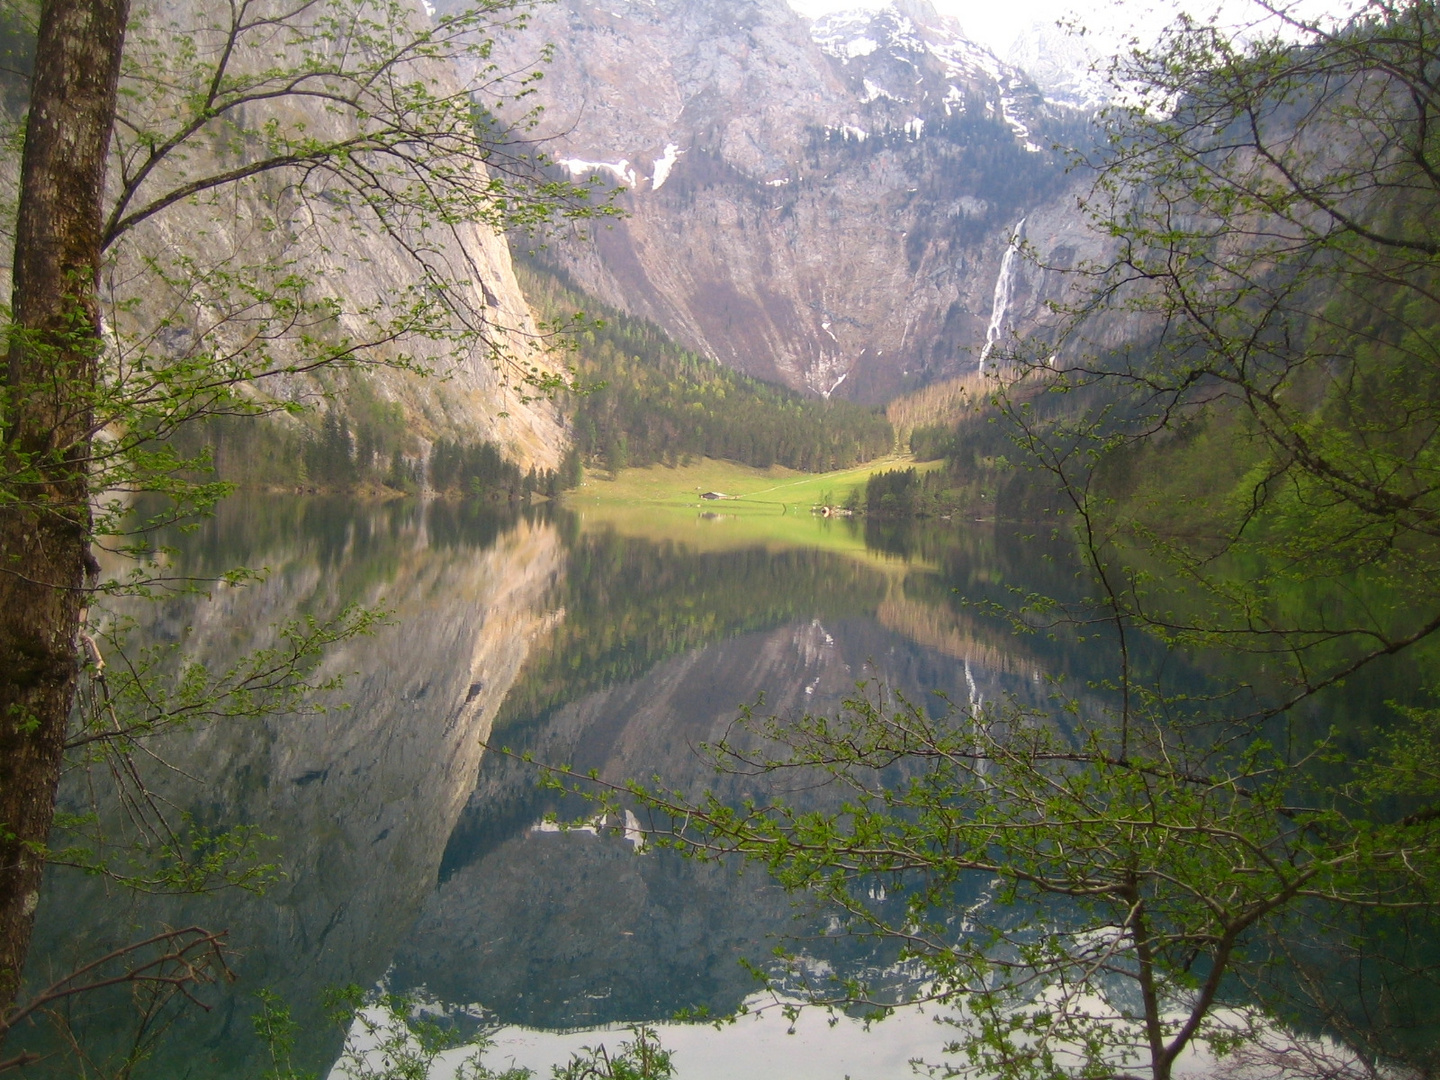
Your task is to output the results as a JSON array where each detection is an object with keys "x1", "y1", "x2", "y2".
[{"x1": 478, "y1": 0, "x2": 1096, "y2": 402}]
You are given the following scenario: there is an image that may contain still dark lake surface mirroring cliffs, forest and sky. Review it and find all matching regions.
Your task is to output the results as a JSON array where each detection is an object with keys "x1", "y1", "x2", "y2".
[{"x1": 22, "y1": 495, "x2": 1416, "y2": 1080}]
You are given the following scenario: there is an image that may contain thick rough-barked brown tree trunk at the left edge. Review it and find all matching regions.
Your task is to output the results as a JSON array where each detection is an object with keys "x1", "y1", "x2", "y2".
[{"x1": 0, "y1": 0, "x2": 130, "y2": 1012}]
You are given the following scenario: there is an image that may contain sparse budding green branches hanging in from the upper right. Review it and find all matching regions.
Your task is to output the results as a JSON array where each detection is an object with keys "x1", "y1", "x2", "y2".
[{"x1": 979, "y1": 3, "x2": 1440, "y2": 711}]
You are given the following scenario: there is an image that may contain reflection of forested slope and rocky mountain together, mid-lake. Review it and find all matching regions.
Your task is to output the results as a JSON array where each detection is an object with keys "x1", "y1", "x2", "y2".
[{"x1": 392, "y1": 521, "x2": 1082, "y2": 1028}]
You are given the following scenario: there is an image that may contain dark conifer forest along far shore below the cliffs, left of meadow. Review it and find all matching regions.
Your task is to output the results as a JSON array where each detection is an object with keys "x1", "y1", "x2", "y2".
[{"x1": 171, "y1": 262, "x2": 894, "y2": 501}]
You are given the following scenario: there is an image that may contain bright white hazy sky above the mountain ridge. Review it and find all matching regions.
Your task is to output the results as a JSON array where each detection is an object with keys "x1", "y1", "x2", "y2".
[{"x1": 789, "y1": 0, "x2": 1354, "y2": 56}]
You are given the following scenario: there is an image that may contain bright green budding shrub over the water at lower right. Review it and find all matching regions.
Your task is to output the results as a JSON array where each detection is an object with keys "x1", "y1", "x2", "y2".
[{"x1": 552, "y1": 685, "x2": 1440, "y2": 1079}]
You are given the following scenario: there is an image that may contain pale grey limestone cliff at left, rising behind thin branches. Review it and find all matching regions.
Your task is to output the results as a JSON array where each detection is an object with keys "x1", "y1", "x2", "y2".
[{"x1": 0, "y1": 0, "x2": 566, "y2": 468}]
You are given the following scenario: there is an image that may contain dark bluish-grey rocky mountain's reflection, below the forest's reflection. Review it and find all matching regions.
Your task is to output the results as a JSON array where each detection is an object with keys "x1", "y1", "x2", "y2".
[{"x1": 393, "y1": 616, "x2": 1027, "y2": 1028}]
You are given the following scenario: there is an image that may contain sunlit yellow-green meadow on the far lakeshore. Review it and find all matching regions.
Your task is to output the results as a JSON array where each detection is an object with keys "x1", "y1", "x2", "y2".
[{"x1": 564, "y1": 456, "x2": 940, "y2": 566}]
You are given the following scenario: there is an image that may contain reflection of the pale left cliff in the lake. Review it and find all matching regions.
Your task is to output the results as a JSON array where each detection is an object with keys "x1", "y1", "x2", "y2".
[{"x1": 19, "y1": 498, "x2": 564, "y2": 1076}]
